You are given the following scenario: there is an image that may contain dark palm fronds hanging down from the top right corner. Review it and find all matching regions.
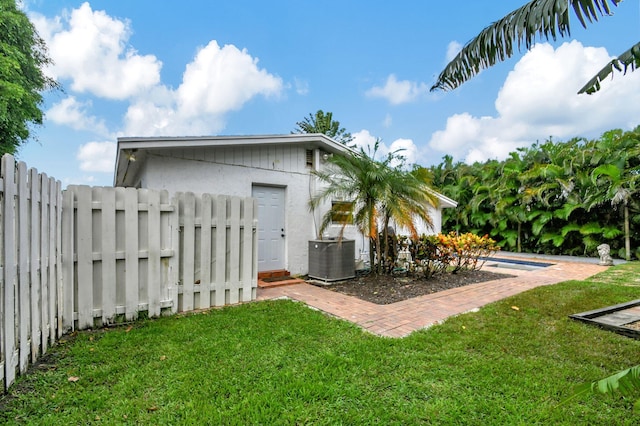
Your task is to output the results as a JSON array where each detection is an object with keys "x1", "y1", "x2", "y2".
[{"x1": 431, "y1": 0, "x2": 640, "y2": 94}]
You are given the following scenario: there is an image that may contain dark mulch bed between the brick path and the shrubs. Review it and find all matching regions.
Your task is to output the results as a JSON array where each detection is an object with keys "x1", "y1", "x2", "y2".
[{"x1": 316, "y1": 271, "x2": 513, "y2": 305}]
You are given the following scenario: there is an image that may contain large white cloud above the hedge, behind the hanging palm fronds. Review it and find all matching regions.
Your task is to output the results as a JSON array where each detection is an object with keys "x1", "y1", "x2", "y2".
[{"x1": 429, "y1": 41, "x2": 640, "y2": 162}]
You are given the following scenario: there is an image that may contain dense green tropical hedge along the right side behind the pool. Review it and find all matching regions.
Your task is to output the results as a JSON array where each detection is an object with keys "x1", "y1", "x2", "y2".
[{"x1": 431, "y1": 126, "x2": 640, "y2": 259}]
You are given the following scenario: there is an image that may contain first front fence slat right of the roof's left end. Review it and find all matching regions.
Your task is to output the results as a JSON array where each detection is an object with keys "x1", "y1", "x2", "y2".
[{"x1": 124, "y1": 188, "x2": 139, "y2": 321}]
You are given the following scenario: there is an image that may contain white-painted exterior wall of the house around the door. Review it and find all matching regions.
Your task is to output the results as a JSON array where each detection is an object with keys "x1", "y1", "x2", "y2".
[{"x1": 122, "y1": 145, "x2": 448, "y2": 275}]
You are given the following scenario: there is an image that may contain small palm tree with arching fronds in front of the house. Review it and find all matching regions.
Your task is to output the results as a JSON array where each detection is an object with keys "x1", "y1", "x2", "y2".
[{"x1": 310, "y1": 141, "x2": 436, "y2": 272}]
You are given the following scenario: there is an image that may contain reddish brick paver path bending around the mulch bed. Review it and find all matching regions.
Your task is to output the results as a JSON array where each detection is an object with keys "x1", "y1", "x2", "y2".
[{"x1": 257, "y1": 261, "x2": 607, "y2": 337}]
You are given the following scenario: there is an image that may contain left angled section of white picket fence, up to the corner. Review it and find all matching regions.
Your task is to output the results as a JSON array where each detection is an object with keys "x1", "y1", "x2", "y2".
[{"x1": 0, "y1": 155, "x2": 62, "y2": 389}]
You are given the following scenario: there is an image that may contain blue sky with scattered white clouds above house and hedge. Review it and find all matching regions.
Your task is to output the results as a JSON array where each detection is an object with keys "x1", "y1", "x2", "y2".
[{"x1": 18, "y1": 0, "x2": 640, "y2": 186}]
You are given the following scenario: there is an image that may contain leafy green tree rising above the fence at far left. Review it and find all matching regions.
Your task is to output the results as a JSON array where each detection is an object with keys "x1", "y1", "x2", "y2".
[{"x1": 0, "y1": 0, "x2": 58, "y2": 155}]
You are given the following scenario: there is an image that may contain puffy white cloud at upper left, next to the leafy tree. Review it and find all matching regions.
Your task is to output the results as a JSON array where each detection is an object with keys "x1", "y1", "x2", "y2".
[{"x1": 32, "y1": 3, "x2": 162, "y2": 100}]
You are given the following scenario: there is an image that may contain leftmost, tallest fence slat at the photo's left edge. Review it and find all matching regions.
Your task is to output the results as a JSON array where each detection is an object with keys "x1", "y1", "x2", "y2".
[{"x1": 0, "y1": 155, "x2": 18, "y2": 389}]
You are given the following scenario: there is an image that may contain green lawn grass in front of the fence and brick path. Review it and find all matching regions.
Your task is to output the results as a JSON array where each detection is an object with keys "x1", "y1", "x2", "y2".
[{"x1": 0, "y1": 262, "x2": 640, "y2": 425}]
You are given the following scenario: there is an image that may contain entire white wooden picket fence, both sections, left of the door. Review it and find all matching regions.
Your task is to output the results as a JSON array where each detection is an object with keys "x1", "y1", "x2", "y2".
[{"x1": 0, "y1": 155, "x2": 257, "y2": 389}]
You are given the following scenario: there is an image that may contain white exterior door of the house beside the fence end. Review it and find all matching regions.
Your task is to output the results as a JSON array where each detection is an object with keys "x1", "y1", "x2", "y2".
[{"x1": 251, "y1": 185, "x2": 286, "y2": 271}]
